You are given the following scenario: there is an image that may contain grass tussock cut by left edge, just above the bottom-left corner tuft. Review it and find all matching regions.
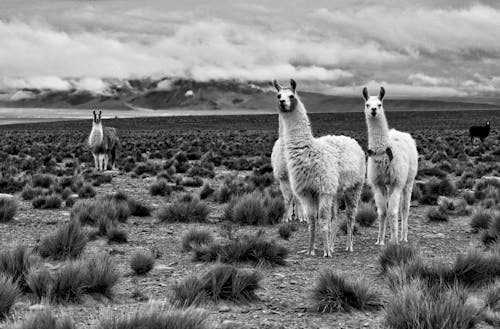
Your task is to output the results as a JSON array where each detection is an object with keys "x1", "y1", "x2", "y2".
[{"x1": 0, "y1": 245, "x2": 33, "y2": 291}]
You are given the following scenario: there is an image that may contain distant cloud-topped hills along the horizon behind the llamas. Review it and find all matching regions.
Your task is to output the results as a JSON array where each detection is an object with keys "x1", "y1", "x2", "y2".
[{"x1": 0, "y1": 79, "x2": 500, "y2": 113}]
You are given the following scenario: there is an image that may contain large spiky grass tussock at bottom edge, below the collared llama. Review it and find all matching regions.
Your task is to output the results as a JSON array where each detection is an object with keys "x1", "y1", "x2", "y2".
[{"x1": 384, "y1": 281, "x2": 480, "y2": 329}]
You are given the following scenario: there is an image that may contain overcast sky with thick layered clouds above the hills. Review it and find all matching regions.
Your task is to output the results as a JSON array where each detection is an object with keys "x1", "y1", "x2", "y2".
[{"x1": 0, "y1": 0, "x2": 500, "y2": 98}]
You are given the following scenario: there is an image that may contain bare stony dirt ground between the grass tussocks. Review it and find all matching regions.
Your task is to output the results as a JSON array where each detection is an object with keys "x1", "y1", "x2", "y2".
[{"x1": 0, "y1": 168, "x2": 489, "y2": 329}]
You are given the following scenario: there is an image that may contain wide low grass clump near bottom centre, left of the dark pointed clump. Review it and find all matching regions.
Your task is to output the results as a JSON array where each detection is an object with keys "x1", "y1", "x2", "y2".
[{"x1": 172, "y1": 264, "x2": 261, "y2": 307}]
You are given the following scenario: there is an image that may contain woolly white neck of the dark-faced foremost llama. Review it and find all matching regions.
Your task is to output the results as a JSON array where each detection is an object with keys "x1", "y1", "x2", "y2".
[{"x1": 280, "y1": 100, "x2": 314, "y2": 151}]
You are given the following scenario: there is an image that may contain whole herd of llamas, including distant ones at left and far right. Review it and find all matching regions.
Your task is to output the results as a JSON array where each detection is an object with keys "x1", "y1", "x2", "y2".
[{"x1": 88, "y1": 79, "x2": 428, "y2": 257}]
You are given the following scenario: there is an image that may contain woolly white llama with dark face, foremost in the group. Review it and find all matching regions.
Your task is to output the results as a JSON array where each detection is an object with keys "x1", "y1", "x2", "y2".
[{"x1": 274, "y1": 80, "x2": 365, "y2": 257}]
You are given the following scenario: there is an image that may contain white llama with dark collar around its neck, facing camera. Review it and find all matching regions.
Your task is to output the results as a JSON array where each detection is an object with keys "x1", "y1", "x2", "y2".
[{"x1": 363, "y1": 87, "x2": 418, "y2": 245}]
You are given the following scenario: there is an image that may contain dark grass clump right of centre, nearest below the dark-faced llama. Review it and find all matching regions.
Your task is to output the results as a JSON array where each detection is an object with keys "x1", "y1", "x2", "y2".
[{"x1": 312, "y1": 270, "x2": 382, "y2": 313}]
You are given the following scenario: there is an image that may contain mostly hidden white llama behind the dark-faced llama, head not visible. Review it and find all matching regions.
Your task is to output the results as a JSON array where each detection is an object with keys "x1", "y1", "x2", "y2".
[{"x1": 271, "y1": 118, "x2": 304, "y2": 222}]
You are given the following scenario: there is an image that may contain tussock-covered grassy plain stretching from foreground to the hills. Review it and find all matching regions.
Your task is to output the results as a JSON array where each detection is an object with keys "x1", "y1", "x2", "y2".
[{"x1": 0, "y1": 111, "x2": 500, "y2": 329}]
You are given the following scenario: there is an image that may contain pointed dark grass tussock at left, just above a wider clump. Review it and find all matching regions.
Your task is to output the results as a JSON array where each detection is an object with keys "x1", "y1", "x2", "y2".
[{"x1": 38, "y1": 220, "x2": 87, "y2": 260}]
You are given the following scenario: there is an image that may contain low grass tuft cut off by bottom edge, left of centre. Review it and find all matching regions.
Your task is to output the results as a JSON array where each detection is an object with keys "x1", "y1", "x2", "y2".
[{"x1": 97, "y1": 306, "x2": 211, "y2": 329}]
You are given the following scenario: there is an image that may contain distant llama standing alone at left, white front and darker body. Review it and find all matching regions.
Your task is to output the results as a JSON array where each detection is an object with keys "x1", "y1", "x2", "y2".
[{"x1": 88, "y1": 111, "x2": 119, "y2": 171}]
